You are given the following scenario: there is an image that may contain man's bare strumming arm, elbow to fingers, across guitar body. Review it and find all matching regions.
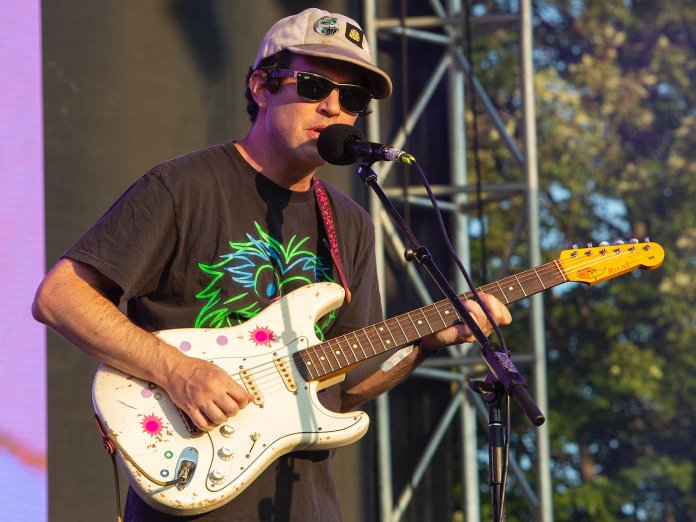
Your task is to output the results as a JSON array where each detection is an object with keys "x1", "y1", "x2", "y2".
[{"x1": 32, "y1": 259, "x2": 253, "y2": 430}]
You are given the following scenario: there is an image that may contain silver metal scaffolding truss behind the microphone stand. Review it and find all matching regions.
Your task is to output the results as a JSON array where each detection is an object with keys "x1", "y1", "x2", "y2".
[{"x1": 363, "y1": 0, "x2": 553, "y2": 522}]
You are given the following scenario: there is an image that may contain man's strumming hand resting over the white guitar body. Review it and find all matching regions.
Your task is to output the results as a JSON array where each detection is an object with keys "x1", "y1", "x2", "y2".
[{"x1": 163, "y1": 357, "x2": 254, "y2": 431}]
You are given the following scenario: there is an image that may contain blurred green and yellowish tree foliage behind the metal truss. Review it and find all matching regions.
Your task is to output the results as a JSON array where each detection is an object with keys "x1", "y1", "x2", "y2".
[{"x1": 462, "y1": 0, "x2": 696, "y2": 521}]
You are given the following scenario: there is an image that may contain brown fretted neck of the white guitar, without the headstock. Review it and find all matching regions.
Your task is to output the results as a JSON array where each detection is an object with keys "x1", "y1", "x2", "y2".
[{"x1": 295, "y1": 261, "x2": 568, "y2": 380}]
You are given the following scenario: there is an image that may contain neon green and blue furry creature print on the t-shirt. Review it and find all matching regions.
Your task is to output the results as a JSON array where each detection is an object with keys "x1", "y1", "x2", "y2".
[{"x1": 195, "y1": 222, "x2": 335, "y2": 340}]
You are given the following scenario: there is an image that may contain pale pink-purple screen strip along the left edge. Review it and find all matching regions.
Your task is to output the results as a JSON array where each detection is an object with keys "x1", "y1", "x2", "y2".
[{"x1": 0, "y1": 0, "x2": 48, "y2": 522}]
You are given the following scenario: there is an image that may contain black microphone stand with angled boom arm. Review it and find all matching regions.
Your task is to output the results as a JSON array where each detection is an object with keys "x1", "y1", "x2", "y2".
[{"x1": 357, "y1": 163, "x2": 545, "y2": 522}]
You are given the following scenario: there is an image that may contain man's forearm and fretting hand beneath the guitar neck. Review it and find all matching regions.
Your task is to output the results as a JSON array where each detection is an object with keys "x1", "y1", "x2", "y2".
[{"x1": 341, "y1": 293, "x2": 512, "y2": 411}]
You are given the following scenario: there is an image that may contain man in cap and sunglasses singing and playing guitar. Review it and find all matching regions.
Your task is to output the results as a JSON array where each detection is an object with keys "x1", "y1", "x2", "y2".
[{"x1": 33, "y1": 9, "x2": 511, "y2": 521}]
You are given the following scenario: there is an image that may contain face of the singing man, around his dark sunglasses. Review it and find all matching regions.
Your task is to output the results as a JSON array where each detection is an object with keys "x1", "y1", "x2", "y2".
[{"x1": 257, "y1": 55, "x2": 370, "y2": 169}]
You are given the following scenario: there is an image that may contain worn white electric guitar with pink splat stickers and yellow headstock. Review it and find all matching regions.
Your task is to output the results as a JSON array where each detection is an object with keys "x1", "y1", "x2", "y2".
[{"x1": 92, "y1": 242, "x2": 664, "y2": 515}]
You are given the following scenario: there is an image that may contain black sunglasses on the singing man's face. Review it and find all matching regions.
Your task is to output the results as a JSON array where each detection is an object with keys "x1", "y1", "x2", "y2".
[{"x1": 269, "y1": 69, "x2": 372, "y2": 114}]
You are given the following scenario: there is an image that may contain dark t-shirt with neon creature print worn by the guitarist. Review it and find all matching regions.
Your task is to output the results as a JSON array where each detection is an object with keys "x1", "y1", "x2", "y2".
[{"x1": 65, "y1": 140, "x2": 381, "y2": 521}]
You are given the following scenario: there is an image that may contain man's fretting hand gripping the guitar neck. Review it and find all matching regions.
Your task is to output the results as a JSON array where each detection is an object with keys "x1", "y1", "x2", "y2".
[{"x1": 421, "y1": 292, "x2": 512, "y2": 351}]
